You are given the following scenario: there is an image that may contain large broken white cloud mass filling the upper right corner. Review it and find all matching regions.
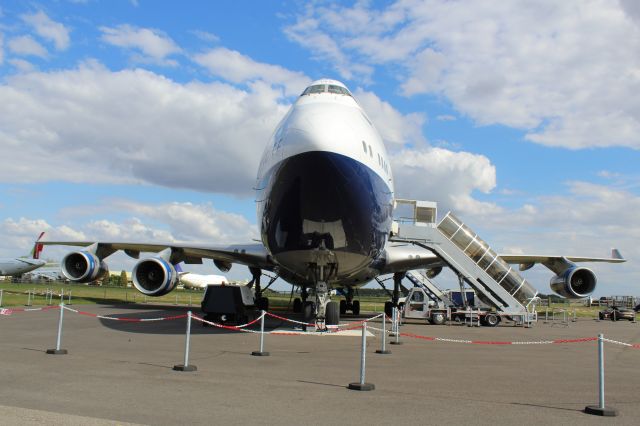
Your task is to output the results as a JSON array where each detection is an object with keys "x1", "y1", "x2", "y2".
[{"x1": 286, "y1": 0, "x2": 640, "y2": 149}]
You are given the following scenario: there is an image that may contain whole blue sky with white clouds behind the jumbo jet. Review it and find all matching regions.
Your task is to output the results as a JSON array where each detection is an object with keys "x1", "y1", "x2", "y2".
[{"x1": 0, "y1": 0, "x2": 640, "y2": 295}]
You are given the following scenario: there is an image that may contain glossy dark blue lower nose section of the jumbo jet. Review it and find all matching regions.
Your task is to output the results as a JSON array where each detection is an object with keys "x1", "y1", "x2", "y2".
[{"x1": 258, "y1": 151, "x2": 393, "y2": 279}]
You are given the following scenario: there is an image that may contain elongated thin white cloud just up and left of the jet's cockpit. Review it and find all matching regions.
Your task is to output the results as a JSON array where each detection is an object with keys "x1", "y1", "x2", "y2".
[{"x1": 193, "y1": 47, "x2": 311, "y2": 96}]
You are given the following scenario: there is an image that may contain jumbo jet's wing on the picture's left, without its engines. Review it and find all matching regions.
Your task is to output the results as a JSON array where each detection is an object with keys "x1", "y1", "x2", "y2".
[{"x1": 40, "y1": 241, "x2": 274, "y2": 270}]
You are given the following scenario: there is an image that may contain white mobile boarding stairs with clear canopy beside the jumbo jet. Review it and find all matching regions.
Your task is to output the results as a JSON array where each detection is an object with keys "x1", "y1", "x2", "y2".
[{"x1": 390, "y1": 199, "x2": 539, "y2": 323}]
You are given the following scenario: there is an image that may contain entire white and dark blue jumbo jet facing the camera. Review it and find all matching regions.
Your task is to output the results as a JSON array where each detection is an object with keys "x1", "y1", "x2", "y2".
[{"x1": 44, "y1": 80, "x2": 624, "y2": 325}]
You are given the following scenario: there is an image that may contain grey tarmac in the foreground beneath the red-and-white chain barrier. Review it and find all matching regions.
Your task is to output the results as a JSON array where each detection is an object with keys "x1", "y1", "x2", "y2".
[{"x1": 0, "y1": 305, "x2": 640, "y2": 425}]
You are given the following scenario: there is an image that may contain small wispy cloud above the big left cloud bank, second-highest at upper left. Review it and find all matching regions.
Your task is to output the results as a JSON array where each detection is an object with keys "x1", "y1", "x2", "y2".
[{"x1": 100, "y1": 25, "x2": 182, "y2": 65}]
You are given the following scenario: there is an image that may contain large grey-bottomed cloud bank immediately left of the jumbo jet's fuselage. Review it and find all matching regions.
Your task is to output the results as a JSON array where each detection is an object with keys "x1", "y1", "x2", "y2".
[{"x1": 0, "y1": 63, "x2": 288, "y2": 194}]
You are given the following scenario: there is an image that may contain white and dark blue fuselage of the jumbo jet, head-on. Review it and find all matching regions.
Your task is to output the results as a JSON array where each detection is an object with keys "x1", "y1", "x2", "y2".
[{"x1": 257, "y1": 80, "x2": 394, "y2": 286}]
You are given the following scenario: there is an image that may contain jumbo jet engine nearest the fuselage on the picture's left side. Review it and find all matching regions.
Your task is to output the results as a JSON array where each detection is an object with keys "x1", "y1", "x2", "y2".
[{"x1": 131, "y1": 257, "x2": 179, "y2": 296}]
